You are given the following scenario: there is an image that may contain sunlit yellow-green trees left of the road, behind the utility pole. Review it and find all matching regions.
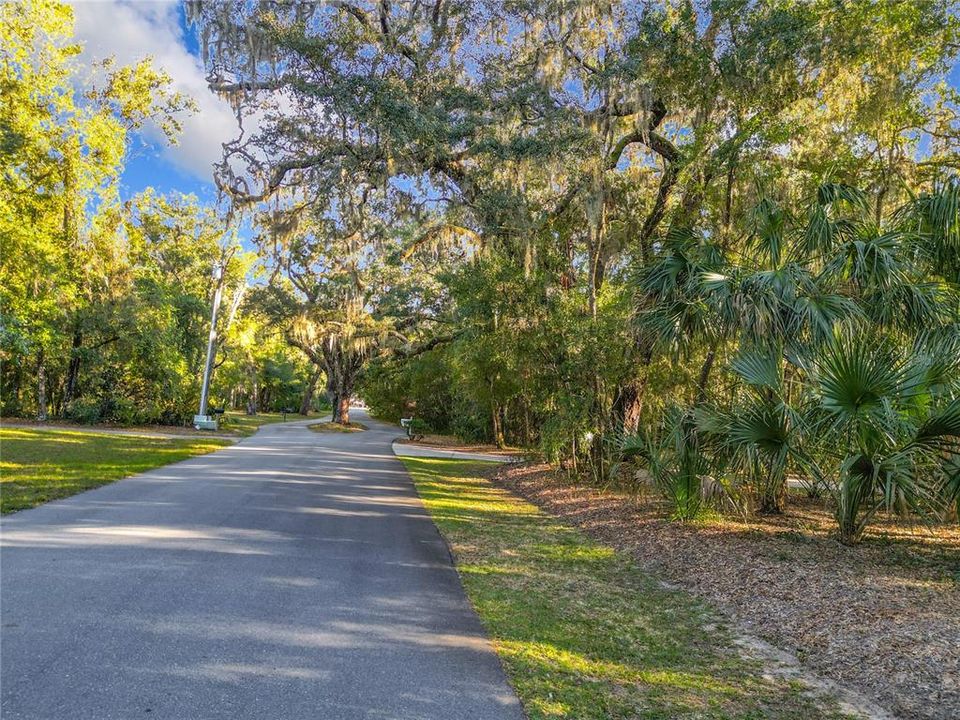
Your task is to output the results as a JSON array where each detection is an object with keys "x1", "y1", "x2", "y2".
[{"x1": 0, "y1": 1, "x2": 309, "y2": 424}]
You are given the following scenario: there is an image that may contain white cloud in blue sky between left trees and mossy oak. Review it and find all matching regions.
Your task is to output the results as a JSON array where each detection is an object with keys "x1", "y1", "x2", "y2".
[{"x1": 72, "y1": 0, "x2": 238, "y2": 182}]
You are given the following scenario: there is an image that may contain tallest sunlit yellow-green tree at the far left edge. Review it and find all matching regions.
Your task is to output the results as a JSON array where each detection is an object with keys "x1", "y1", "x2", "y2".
[{"x1": 0, "y1": 0, "x2": 189, "y2": 419}]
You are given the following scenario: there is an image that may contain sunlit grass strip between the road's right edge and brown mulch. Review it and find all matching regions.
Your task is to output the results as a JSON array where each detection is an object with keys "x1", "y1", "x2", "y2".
[{"x1": 402, "y1": 458, "x2": 844, "y2": 720}]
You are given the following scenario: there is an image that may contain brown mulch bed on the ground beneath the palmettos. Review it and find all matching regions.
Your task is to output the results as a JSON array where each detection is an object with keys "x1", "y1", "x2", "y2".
[{"x1": 495, "y1": 464, "x2": 960, "y2": 720}]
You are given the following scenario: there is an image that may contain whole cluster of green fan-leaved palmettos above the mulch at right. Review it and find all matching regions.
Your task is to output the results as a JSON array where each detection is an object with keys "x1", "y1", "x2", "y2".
[{"x1": 624, "y1": 183, "x2": 960, "y2": 542}]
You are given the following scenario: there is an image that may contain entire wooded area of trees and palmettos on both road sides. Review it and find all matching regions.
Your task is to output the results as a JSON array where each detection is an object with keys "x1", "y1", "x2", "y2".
[{"x1": 0, "y1": 0, "x2": 960, "y2": 542}]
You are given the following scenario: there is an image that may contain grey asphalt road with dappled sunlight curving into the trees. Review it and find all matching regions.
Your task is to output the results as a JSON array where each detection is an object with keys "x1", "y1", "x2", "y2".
[{"x1": 0, "y1": 413, "x2": 523, "y2": 720}]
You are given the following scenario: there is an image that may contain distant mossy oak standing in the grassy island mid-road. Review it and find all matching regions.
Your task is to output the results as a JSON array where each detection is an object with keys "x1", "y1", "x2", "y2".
[{"x1": 251, "y1": 185, "x2": 450, "y2": 423}]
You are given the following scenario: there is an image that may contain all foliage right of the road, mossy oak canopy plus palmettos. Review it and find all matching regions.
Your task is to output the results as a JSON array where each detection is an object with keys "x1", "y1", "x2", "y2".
[{"x1": 192, "y1": 0, "x2": 960, "y2": 541}]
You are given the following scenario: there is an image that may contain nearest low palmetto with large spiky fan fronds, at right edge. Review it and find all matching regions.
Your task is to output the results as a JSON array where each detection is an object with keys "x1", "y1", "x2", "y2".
[{"x1": 809, "y1": 335, "x2": 960, "y2": 541}]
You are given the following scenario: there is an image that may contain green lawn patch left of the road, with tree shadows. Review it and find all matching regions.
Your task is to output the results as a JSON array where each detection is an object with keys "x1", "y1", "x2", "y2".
[{"x1": 0, "y1": 428, "x2": 230, "y2": 513}]
